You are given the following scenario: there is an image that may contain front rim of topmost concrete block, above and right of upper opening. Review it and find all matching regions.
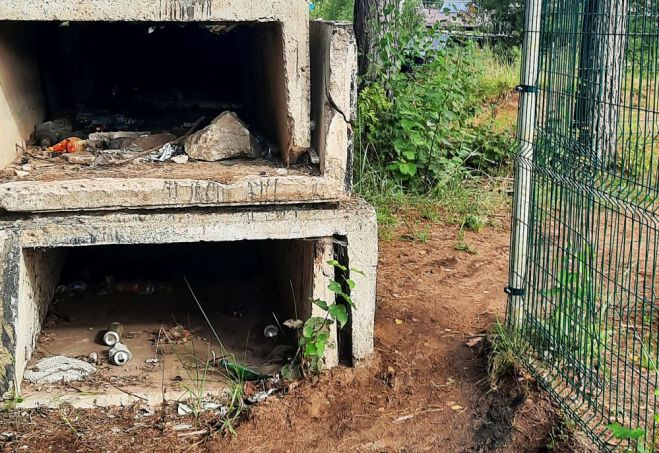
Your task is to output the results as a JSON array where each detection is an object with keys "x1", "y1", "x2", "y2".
[{"x1": 0, "y1": 0, "x2": 310, "y2": 162}]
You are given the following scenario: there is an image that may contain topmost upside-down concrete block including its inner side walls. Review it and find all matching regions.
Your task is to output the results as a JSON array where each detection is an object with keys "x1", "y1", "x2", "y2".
[{"x1": 0, "y1": 0, "x2": 310, "y2": 165}]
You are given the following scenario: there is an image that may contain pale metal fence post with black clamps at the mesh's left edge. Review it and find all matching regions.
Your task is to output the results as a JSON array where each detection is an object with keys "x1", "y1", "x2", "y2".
[{"x1": 507, "y1": 0, "x2": 542, "y2": 328}]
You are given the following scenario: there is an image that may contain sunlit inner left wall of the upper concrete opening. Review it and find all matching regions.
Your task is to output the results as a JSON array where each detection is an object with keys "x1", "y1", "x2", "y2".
[{"x1": 0, "y1": 24, "x2": 44, "y2": 168}]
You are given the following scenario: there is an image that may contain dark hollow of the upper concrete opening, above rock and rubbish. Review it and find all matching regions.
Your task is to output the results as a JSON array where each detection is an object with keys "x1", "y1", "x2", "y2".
[{"x1": 0, "y1": 21, "x2": 290, "y2": 171}]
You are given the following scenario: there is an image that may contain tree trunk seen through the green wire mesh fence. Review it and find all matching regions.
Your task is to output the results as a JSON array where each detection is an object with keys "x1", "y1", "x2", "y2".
[{"x1": 575, "y1": 0, "x2": 629, "y2": 168}]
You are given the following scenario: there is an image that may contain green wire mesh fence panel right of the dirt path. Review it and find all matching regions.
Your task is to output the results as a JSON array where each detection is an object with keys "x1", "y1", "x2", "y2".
[{"x1": 507, "y1": 0, "x2": 659, "y2": 451}]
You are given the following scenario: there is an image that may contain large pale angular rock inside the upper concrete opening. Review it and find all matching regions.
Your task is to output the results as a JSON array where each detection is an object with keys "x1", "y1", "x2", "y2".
[{"x1": 185, "y1": 111, "x2": 261, "y2": 162}]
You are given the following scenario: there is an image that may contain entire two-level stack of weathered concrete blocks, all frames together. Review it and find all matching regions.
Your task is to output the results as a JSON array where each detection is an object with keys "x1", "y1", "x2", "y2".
[{"x1": 0, "y1": 13, "x2": 377, "y2": 404}]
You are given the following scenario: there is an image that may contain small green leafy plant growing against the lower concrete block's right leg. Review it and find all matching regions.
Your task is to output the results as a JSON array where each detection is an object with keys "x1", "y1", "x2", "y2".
[{"x1": 282, "y1": 260, "x2": 361, "y2": 376}]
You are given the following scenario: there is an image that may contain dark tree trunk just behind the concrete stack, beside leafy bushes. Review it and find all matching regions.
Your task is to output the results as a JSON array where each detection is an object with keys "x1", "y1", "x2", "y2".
[{"x1": 354, "y1": 0, "x2": 396, "y2": 77}]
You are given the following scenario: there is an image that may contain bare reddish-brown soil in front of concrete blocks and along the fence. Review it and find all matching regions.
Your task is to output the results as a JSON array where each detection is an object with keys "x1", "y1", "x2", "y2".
[{"x1": 0, "y1": 213, "x2": 583, "y2": 452}]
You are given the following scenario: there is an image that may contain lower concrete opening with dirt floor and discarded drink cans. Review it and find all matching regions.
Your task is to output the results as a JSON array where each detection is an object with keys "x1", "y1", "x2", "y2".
[{"x1": 15, "y1": 240, "x2": 318, "y2": 404}]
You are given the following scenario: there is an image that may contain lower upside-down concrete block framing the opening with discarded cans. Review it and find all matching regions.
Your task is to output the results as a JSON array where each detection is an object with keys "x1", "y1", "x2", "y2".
[{"x1": 0, "y1": 200, "x2": 377, "y2": 391}]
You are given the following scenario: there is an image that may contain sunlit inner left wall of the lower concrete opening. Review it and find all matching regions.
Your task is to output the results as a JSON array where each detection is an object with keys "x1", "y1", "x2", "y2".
[{"x1": 15, "y1": 249, "x2": 64, "y2": 382}]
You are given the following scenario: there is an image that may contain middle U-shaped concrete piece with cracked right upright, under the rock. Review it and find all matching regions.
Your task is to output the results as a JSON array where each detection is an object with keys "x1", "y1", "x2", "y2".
[{"x1": 0, "y1": 19, "x2": 357, "y2": 212}]
